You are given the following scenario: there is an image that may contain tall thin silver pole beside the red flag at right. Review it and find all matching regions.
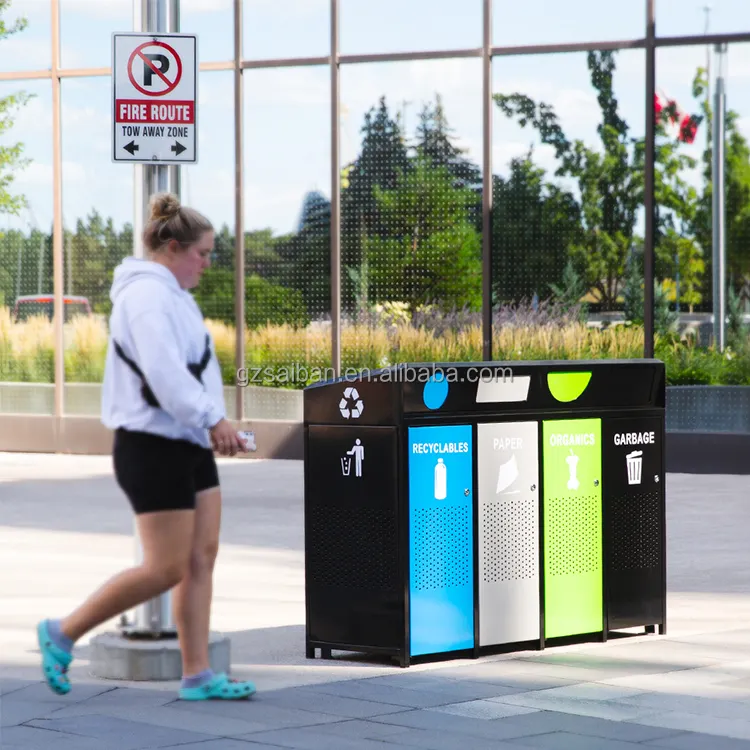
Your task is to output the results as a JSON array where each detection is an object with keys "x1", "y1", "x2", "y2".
[{"x1": 712, "y1": 44, "x2": 726, "y2": 351}]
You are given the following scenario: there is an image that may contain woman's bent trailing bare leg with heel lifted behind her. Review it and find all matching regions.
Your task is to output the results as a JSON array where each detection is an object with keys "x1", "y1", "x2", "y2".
[{"x1": 60, "y1": 510, "x2": 195, "y2": 642}]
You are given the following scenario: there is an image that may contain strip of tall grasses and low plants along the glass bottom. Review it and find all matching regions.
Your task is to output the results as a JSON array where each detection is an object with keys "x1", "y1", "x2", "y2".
[{"x1": 0, "y1": 303, "x2": 750, "y2": 388}]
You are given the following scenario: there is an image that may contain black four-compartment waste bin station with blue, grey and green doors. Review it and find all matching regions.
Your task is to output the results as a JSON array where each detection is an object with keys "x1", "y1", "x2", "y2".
[{"x1": 304, "y1": 359, "x2": 666, "y2": 667}]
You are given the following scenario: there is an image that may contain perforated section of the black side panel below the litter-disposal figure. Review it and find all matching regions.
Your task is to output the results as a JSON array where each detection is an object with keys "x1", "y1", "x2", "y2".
[{"x1": 306, "y1": 506, "x2": 398, "y2": 591}]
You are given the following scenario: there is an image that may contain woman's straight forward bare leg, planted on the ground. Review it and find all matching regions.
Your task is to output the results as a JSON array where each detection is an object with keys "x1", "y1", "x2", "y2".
[{"x1": 172, "y1": 487, "x2": 221, "y2": 677}]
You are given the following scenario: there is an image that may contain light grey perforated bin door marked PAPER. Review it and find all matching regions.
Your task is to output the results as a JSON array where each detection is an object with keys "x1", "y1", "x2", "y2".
[{"x1": 477, "y1": 422, "x2": 540, "y2": 646}]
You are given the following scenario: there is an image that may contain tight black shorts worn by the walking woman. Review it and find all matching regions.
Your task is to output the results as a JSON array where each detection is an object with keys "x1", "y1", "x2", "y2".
[{"x1": 112, "y1": 428, "x2": 219, "y2": 514}]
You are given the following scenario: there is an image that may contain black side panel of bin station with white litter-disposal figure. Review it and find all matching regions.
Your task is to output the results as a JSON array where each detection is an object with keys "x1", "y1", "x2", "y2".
[{"x1": 305, "y1": 428, "x2": 406, "y2": 649}]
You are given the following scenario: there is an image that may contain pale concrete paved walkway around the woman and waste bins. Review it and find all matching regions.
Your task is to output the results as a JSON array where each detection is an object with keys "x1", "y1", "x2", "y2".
[{"x1": 0, "y1": 454, "x2": 750, "y2": 750}]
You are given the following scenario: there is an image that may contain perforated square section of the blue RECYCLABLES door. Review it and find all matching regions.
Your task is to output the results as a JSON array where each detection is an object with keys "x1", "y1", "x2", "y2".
[{"x1": 412, "y1": 505, "x2": 472, "y2": 591}]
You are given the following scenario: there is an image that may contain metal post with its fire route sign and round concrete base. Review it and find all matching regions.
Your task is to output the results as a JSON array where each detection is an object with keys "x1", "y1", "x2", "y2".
[{"x1": 97, "y1": 0, "x2": 228, "y2": 681}]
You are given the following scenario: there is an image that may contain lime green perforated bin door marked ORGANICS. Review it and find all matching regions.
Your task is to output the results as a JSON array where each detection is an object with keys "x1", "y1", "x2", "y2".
[{"x1": 542, "y1": 419, "x2": 603, "y2": 638}]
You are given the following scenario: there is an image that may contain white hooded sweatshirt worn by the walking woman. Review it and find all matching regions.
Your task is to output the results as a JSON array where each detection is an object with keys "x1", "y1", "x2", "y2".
[{"x1": 102, "y1": 257, "x2": 226, "y2": 448}]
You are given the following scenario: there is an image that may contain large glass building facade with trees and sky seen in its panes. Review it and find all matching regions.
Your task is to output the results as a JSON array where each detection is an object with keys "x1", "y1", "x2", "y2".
[{"x1": 0, "y1": 0, "x2": 750, "y2": 452}]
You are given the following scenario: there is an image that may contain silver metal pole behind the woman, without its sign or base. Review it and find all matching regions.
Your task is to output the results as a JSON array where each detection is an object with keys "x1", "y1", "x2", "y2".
[{"x1": 121, "y1": 0, "x2": 180, "y2": 638}]
